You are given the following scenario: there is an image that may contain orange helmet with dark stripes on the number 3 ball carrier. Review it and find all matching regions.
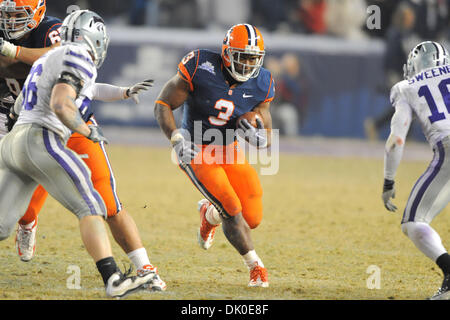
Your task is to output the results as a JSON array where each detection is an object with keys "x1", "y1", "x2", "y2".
[{"x1": 222, "y1": 24, "x2": 265, "y2": 82}]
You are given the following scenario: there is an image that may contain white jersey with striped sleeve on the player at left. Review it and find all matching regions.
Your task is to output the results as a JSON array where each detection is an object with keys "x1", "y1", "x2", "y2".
[{"x1": 16, "y1": 43, "x2": 97, "y2": 141}]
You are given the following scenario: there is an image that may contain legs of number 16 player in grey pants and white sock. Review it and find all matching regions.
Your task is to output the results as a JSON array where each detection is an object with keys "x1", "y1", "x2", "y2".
[{"x1": 402, "y1": 139, "x2": 450, "y2": 299}]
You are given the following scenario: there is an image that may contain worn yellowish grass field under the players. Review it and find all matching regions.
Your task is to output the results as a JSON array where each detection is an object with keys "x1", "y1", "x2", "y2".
[{"x1": 0, "y1": 145, "x2": 450, "y2": 300}]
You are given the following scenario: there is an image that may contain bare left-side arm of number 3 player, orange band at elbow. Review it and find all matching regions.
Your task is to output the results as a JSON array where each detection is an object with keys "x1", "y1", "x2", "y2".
[{"x1": 154, "y1": 74, "x2": 190, "y2": 140}]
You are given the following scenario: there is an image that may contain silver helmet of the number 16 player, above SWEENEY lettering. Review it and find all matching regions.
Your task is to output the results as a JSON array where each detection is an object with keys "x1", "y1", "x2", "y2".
[{"x1": 403, "y1": 41, "x2": 450, "y2": 80}]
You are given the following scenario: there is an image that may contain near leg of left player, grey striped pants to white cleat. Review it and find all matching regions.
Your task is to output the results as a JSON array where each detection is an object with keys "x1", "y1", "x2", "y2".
[{"x1": 27, "y1": 126, "x2": 153, "y2": 297}]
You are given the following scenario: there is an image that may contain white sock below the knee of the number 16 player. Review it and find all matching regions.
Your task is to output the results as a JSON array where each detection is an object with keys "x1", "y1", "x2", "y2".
[{"x1": 402, "y1": 222, "x2": 447, "y2": 261}]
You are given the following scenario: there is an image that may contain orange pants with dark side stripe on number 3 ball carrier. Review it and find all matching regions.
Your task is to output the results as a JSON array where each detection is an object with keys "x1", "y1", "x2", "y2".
[{"x1": 181, "y1": 142, "x2": 263, "y2": 229}]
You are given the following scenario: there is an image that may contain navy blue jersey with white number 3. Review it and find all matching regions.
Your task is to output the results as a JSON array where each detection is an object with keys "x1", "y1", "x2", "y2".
[{"x1": 178, "y1": 49, "x2": 275, "y2": 145}]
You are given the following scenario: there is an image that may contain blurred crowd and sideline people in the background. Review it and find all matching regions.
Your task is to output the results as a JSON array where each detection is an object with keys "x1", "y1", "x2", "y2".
[{"x1": 47, "y1": 0, "x2": 450, "y2": 139}]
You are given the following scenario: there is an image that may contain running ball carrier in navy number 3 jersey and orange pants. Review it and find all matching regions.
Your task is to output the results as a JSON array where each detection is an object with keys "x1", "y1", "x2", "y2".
[{"x1": 155, "y1": 24, "x2": 275, "y2": 287}]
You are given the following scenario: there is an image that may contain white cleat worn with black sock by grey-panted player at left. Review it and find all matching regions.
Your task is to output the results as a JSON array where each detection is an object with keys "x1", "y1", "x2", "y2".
[{"x1": 105, "y1": 268, "x2": 154, "y2": 299}]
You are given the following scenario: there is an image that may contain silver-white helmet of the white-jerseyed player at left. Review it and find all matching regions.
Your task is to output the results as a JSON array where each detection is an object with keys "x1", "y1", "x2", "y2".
[{"x1": 61, "y1": 10, "x2": 109, "y2": 68}]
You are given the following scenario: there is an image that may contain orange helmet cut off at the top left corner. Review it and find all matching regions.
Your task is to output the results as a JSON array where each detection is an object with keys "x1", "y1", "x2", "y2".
[{"x1": 0, "y1": 0, "x2": 46, "y2": 39}]
